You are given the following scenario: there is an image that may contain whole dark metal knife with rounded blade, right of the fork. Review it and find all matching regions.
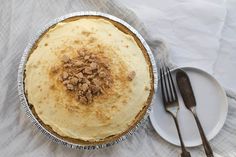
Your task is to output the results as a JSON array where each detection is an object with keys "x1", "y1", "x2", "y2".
[{"x1": 176, "y1": 69, "x2": 214, "y2": 157}]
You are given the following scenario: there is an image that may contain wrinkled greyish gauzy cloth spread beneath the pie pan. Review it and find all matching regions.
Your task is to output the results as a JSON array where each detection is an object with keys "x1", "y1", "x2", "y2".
[{"x1": 0, "y1": 0, "x2": 236, "y2": 157}]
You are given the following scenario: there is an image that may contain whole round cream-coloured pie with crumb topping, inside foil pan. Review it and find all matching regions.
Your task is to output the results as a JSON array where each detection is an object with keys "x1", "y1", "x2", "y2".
[{"x1": 24, "y1": 16, "x2": 154, "y2": 143}]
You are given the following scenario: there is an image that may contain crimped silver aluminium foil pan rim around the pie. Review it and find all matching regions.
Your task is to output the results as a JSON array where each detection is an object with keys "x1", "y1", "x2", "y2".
[{"x1": 18, "y1": 11, "x2": 158, "y2": 150}]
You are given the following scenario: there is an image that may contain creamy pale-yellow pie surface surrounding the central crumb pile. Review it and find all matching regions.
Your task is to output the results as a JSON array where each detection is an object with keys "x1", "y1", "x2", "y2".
[{"x1": 25, "y1": 15, "x2": 153, "y2": 143}]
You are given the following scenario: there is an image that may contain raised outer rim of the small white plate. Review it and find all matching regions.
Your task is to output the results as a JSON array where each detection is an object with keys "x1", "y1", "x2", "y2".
[{"x1": 149, "y1": 66, "x2": 229, "y2": 148}]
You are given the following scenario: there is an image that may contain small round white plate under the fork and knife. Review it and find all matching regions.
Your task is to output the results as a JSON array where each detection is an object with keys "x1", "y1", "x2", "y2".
[{"x1": 150, "y1": 67, "x2": 228, "y2": 147}]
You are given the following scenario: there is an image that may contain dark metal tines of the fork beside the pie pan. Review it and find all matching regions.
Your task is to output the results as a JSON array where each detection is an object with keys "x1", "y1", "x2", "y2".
[{"x1": 160, "y1": 67, "x2": 178, "y2": 105}]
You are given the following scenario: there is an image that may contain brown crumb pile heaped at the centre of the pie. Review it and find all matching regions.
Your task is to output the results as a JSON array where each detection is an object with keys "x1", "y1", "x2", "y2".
[{"x1": 56, "y1": 50, "x2": 113, "y2": 104}]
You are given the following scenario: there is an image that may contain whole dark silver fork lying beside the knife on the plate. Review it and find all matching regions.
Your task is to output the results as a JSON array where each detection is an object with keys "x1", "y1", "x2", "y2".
[{"x1": 160, "y1": 67, "x2": 191, "y2": 157}]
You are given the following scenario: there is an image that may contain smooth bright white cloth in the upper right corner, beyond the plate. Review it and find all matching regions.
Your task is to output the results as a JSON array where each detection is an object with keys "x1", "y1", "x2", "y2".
[{"x1": 122, "y1": 0, "x2": 236, "y2": 92}]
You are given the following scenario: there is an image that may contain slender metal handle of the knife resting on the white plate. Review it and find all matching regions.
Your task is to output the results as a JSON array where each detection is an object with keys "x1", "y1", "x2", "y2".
[{"x1": 192, "y1": 111, "x2": 214, "y2": 157}]
